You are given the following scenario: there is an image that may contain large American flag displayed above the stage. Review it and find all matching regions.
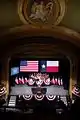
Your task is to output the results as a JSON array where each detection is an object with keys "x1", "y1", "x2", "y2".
[{"x1": 20, "y1": 60, "x2": 38, "y2": 72}]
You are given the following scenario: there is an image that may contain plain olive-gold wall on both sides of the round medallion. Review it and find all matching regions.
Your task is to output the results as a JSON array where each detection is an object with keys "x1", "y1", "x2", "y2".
[{"x1": 0, "y1": 0, "x2": 80, "y2": 32}]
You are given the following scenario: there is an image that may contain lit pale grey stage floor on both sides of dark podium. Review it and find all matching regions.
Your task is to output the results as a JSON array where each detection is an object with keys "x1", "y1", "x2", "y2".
[{"x1": 10, "y1": 85, "x2": 68, "y2": 96}]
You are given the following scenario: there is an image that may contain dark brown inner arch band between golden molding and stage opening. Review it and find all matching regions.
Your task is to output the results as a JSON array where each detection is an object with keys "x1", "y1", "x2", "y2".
[{"x1": 1, "y1": 41, "x2": 77, "y2": 58}]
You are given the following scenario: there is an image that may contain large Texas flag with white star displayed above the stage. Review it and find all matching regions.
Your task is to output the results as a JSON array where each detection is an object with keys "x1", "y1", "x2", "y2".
[{"x1": 40, "y1": 61, "x2": 59, "y2": 72}]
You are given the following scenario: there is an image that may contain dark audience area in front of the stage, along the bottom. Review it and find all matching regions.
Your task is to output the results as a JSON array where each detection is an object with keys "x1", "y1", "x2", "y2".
[{"x1": 0, "y1": 96, "x2": 80, "y2": 120}]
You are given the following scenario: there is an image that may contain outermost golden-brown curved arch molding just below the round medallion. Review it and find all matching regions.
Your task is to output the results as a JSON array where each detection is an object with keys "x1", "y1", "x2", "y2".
[{"x1": 0, "y1": 25, "x2": 80, "y2": 47}]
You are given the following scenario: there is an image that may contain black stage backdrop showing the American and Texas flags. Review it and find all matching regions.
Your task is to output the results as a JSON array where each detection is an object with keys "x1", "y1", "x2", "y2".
[{"x1": 9, "y1": 57, "x2": 70, "y2": 89}]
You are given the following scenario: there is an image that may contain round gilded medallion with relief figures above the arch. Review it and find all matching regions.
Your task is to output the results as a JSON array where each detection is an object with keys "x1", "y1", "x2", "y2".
[{"x1": 18, "y1": 0, "x2": 66, "y2": 26}]
